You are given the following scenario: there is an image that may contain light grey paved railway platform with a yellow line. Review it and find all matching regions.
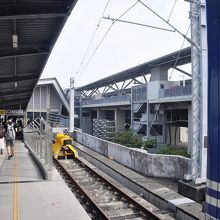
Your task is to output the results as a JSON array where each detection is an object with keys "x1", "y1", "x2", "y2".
[{"x1": 0, "y1": 141, "x2": 90, "y2": 220}]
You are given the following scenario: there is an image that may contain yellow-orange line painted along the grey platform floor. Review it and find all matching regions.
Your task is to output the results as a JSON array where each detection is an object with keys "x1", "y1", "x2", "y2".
[{"x1": 13, "y1": 146, "x2": 20, "y2": 220}]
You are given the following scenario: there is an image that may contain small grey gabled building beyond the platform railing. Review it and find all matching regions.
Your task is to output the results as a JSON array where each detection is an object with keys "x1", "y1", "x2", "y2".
[{"x1": 24, "y1": 78, "x2": 69, "y2": 126}]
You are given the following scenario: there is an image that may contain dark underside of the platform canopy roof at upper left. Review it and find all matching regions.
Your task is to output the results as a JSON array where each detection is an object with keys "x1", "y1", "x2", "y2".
[{"x1": 0, "y1": 0, "x2": 77, "y2": 109}]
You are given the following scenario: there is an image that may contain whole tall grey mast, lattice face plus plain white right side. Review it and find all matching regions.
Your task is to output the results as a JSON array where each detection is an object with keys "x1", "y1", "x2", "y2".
[{"x1": 190, "y1": 0, "x2": 207, "y2": 182}]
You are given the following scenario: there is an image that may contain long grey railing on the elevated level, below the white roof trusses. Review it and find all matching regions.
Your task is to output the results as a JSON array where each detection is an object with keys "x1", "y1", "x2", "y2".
[{"x1": 82, "y1": 94, "x2": 131, "y2": 105}]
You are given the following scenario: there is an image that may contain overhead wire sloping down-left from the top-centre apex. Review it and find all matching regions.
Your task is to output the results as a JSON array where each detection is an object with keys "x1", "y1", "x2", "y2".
[{"x1": 78, "y1": 1, "x2": 138, "y2": 80}]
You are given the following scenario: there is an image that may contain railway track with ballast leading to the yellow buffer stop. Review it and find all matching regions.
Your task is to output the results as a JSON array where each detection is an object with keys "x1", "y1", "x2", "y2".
[{"x1": 54, "y1": 158, "x2": 170, "y2": 220}]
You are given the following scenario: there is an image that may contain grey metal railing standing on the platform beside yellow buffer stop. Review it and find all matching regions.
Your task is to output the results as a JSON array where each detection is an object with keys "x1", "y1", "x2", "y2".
[{"x1": 23, "y1": 118, "x2": 53, "y2": 179}]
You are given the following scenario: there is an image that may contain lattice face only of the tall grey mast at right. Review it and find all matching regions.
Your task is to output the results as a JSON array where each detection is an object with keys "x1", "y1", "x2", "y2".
[{"x1": 190, "y1": 1, "x2": 202, "y2": 179}]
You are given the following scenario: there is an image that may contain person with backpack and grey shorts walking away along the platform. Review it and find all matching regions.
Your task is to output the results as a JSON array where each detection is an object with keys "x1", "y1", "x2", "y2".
[{"x1": 5, "y1": 120, "x2": 15, "y2": 160}]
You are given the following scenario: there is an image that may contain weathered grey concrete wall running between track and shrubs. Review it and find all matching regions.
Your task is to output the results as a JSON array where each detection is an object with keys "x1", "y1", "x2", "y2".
[{"x1": 74, "y1": 131, "x2": 190, "y2": 179}]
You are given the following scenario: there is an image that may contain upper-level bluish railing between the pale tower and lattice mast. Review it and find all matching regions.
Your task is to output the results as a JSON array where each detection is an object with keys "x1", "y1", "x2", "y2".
[{"x1": 159, "y1": 85, "x2": 192, "y2": 98}]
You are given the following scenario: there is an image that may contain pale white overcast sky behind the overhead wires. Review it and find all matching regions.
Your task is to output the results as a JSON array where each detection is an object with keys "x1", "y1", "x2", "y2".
[{"x1": 41, "y1": 0, "x2": 190, "y2": 89}]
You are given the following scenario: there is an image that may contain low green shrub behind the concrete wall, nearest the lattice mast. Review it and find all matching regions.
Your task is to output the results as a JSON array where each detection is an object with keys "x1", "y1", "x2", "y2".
[{"x1": 156, "y1": 146, "x2": 191, "y2": 158}]
